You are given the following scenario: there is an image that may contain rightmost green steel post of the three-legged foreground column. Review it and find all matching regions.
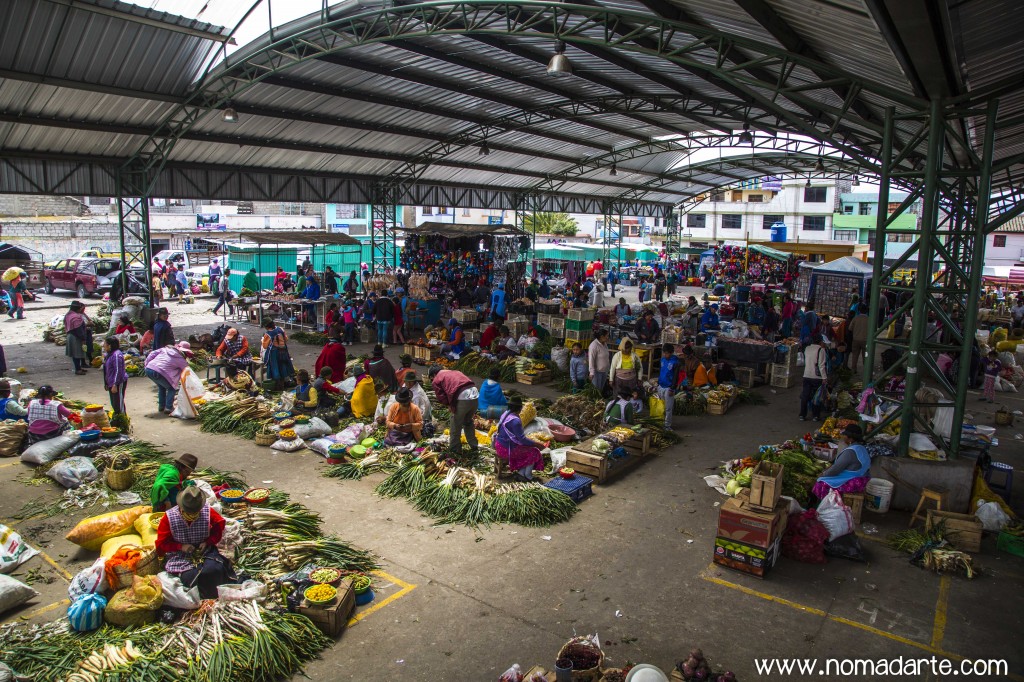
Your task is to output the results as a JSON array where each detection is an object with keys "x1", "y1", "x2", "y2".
[{"x1": 949, "y1": 100, "x2": 998, "y2": 456}]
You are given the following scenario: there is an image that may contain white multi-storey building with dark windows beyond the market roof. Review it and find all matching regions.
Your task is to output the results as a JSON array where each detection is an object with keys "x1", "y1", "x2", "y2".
[{"x1": 681, "y1": 178, "x2": 835, "y2": 247}]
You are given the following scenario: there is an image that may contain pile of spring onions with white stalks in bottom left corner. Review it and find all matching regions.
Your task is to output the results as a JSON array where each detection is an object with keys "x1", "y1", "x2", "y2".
[{"x1": 0, "y1": 600, "x2": 331, "y2": 682}]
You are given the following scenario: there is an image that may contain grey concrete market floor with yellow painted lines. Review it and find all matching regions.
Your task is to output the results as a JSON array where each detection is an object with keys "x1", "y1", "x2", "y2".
[{"x1": 0, "y1": 288, "x2": 1024, "y2": 682}]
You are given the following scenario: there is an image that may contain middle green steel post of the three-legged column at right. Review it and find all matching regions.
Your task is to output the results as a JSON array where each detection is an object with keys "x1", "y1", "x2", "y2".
[{"x1": 898, "y1": 99, "x2": 945, "y2": 456}]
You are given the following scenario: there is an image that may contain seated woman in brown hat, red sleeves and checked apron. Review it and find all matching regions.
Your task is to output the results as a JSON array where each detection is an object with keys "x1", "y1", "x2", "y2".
[{"x1": 156, "y1": 485, "x2": 238, "y2": 599}]
